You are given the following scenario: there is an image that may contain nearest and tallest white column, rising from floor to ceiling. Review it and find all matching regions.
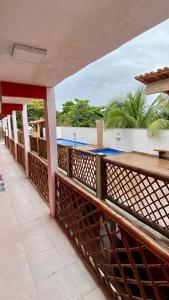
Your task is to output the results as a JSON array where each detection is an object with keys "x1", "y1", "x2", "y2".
[{"x1": 44, "y1": 88, "x2": 58, "y2": 217}]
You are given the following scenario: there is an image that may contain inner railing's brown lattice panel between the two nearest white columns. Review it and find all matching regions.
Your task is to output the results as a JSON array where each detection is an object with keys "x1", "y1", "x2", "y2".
[{"x1": 28, "y1": 152, "x2": 49, "y2": 201}]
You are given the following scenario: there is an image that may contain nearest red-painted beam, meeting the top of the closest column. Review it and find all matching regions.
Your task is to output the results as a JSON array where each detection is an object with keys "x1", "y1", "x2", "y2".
[{"x1": 1, "y1": 81, "x2": 47, "y2": 100}]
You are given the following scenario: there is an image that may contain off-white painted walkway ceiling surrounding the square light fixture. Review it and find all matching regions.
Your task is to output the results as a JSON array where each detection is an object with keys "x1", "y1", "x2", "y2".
[{"x1": 0, "y1": 0, "x2": 169, "y2": 87}]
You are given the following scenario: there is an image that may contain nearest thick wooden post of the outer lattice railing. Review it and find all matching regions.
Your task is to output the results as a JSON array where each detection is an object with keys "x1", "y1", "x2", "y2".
[{"x1": 96, "y1": 154, "x2": 106, "y2": 200}]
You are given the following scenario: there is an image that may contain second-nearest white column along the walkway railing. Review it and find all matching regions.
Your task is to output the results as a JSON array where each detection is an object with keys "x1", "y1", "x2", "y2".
[{"x1": 22, "y1": 104, "x2": 30, "y2": 178}]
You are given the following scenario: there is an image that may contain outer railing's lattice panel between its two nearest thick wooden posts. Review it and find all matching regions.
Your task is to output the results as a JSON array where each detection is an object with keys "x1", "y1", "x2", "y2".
[{"x1": 71, "y1": 149, "x2": 96, "y2": 191}]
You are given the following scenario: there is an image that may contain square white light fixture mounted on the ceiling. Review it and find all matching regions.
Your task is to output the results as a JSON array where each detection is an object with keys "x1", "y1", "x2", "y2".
[{"x1": 12, "y1": 43, "x2": 47, "y2": 64}]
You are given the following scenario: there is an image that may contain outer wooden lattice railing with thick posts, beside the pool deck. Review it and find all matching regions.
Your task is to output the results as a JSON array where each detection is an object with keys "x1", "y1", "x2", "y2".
[{"x1": 25, "y1": 135, "x2": 169, "y2": 238}]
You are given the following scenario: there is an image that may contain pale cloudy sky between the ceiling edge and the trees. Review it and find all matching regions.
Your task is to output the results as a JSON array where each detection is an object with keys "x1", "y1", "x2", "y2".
[{"x1": 55, "y1": 19, "x2": 169, "y2": 110}]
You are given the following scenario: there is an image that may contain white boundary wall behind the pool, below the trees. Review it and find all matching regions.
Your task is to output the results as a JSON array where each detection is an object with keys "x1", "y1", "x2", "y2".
[{"x1": 57, "y1": 127, "x2": 169, "y2": 154}]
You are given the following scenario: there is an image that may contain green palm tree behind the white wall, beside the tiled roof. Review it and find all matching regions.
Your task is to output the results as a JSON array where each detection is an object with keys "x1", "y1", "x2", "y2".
[{"x1": 105, "y1": 88, "x2": 169, "y2": 136}]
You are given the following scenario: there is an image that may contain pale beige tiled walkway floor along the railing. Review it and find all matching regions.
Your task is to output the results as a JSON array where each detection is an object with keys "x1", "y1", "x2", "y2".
[{"x1": 0, "y1": 144, "x2": 107, "y2": 300}]
